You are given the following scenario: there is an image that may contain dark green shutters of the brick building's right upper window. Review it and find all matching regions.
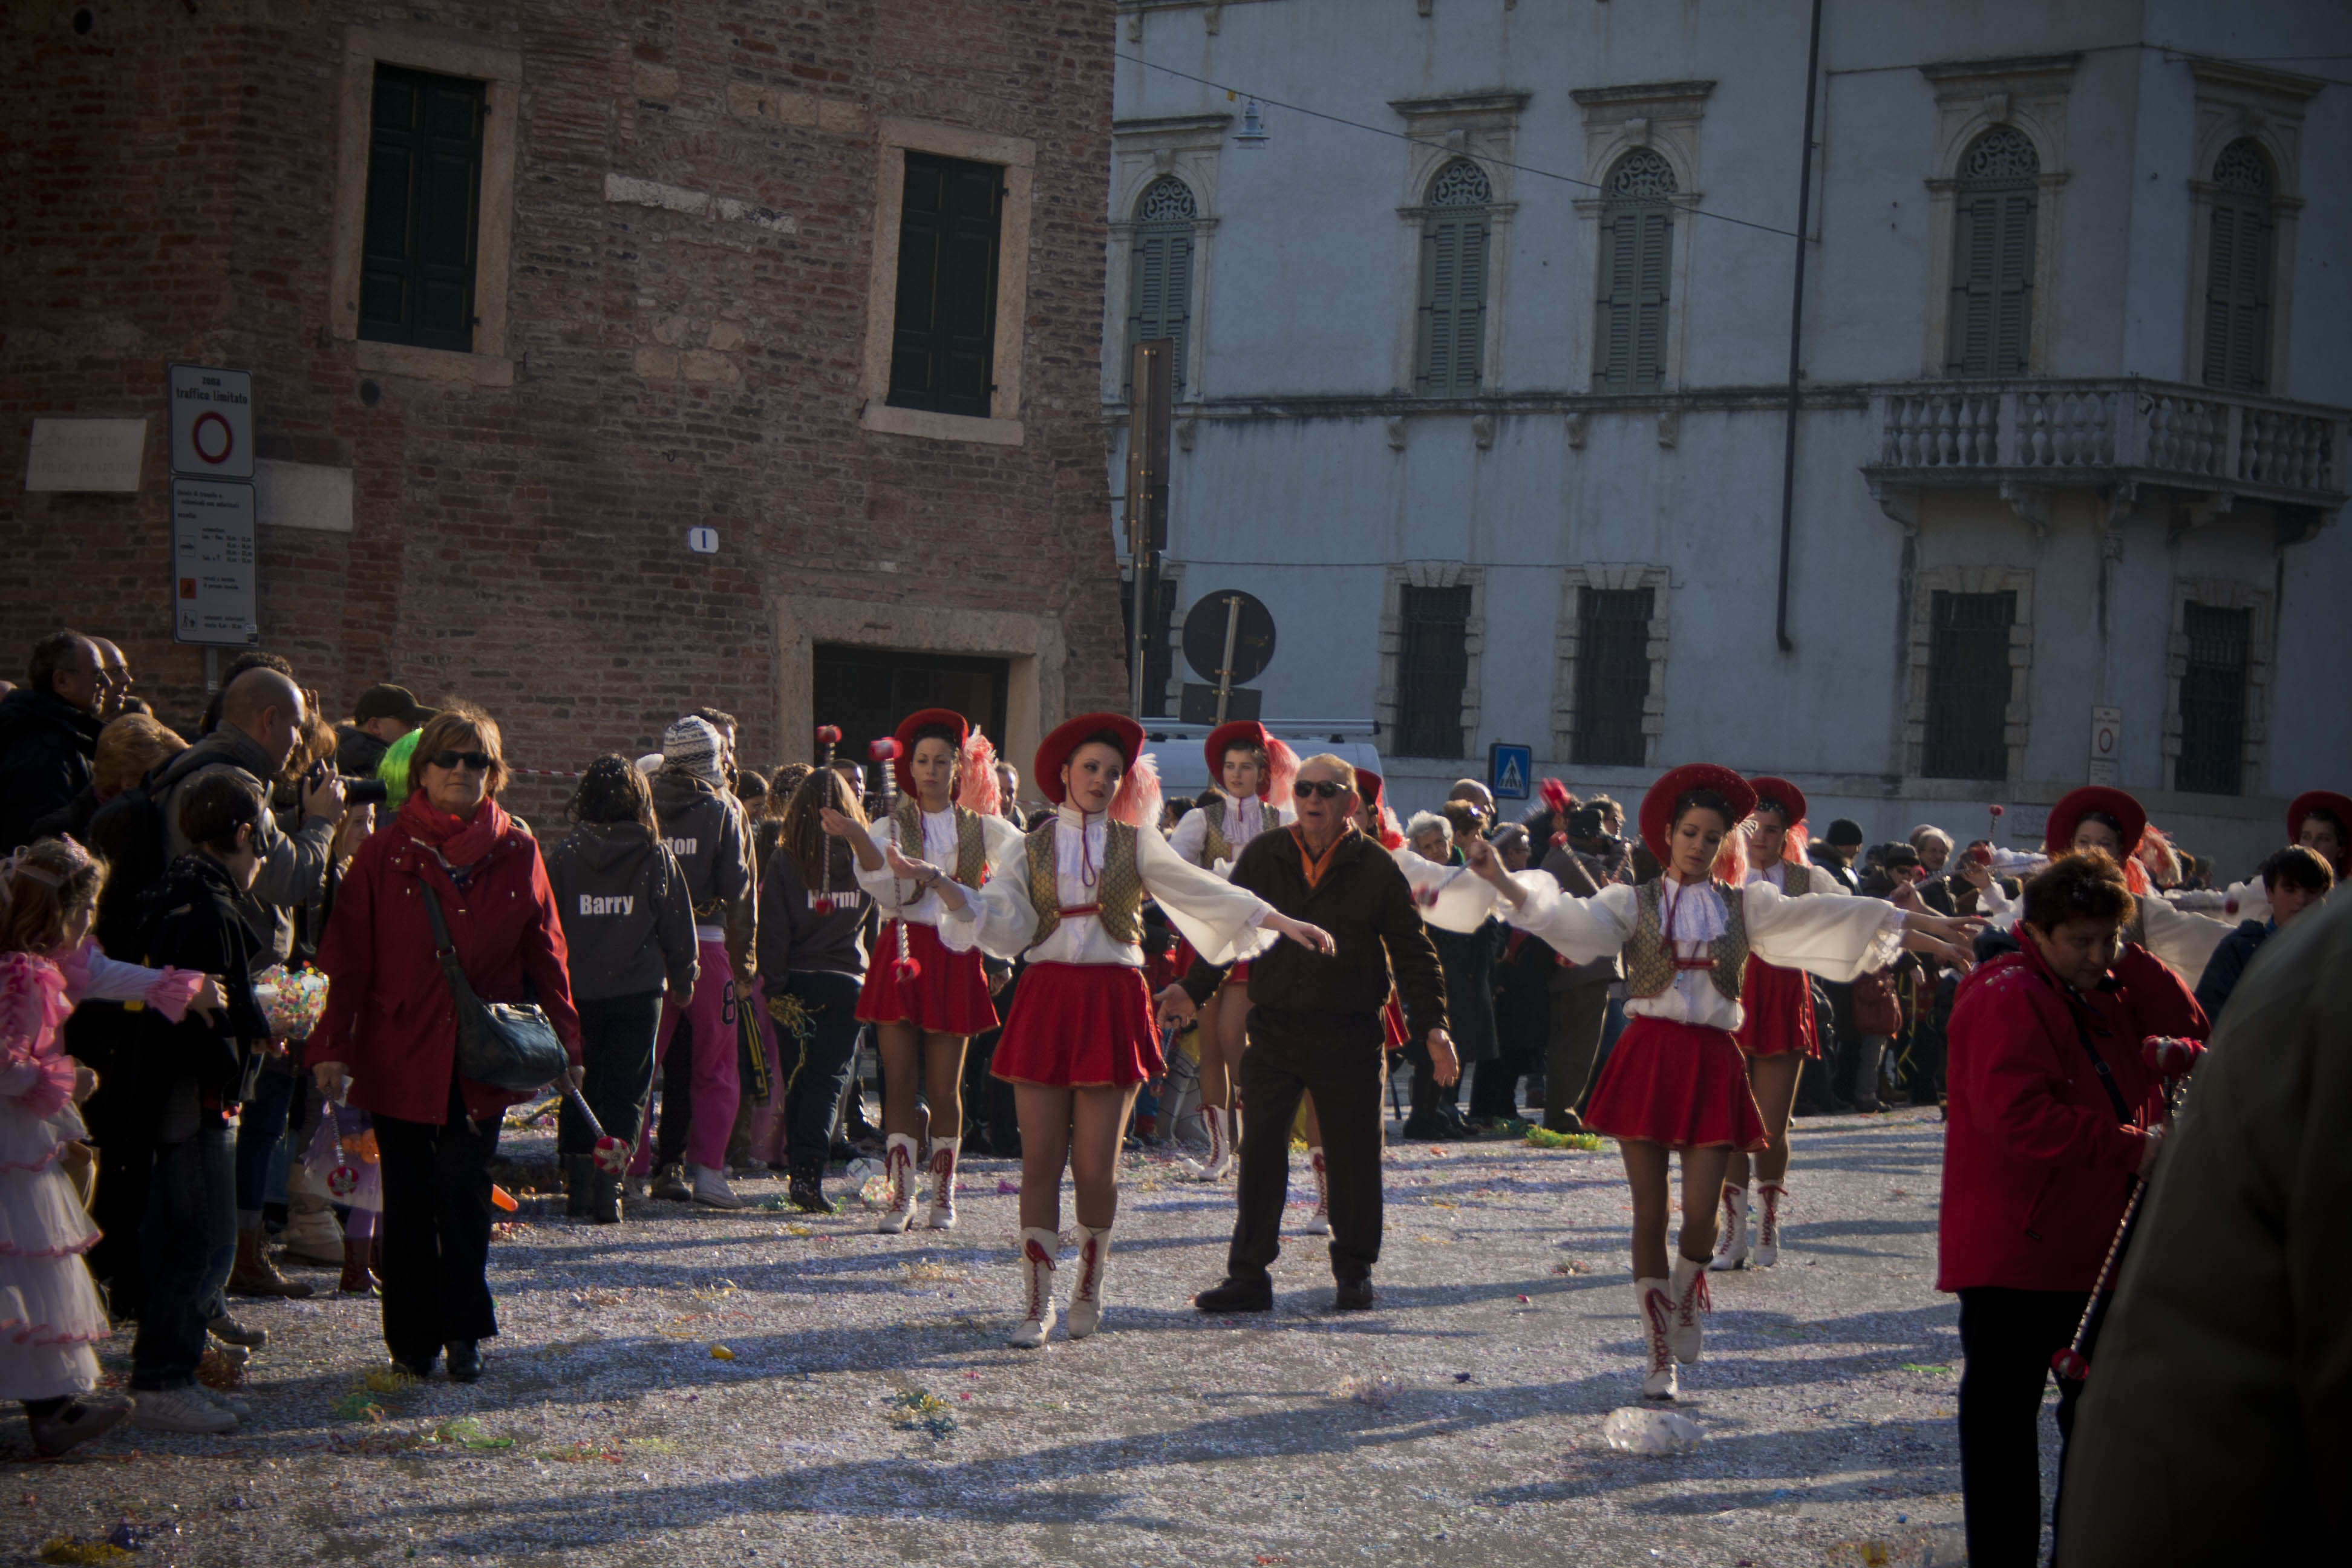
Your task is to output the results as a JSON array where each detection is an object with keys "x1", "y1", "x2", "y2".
[{"x1": 889, "y1": 153, "x2": 1004, "y2": 419}]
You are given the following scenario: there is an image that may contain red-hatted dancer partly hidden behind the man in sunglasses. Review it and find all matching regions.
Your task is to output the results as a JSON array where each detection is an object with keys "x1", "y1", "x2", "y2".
[{"x1": 1169, "y1": 719, "x2": 1298, "y2": 1183}]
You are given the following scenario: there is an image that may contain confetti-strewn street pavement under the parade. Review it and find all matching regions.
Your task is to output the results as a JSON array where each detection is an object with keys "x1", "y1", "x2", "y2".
[{"x1": 0, "y1": 1112, "x2": 2013, "y2": 1568}]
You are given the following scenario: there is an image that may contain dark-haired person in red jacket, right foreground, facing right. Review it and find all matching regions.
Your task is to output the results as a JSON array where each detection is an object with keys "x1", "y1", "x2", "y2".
[{"x1": 1936, "y1": 851, "x2": 2204, "y2": 1568}]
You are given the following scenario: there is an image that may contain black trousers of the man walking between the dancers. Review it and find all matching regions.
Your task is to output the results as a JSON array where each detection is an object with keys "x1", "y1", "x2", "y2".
[{"x1": 1226, "y1": 1006, "x2": 1383, "y2": 1281}]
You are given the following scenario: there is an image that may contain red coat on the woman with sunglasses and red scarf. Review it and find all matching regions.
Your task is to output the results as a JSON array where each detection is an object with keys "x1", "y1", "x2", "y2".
[{"x1": 304, "y1": 794, "x2": 581, "y2": 1124}]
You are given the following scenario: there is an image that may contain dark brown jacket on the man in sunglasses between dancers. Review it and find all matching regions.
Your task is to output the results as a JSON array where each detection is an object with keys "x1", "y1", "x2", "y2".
[{"x1": 1183, "y1": 830, "x2": 1446, "y2": 1039}]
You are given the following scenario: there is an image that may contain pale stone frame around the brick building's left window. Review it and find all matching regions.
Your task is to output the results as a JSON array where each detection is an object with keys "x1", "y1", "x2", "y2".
[{"x1": 327, "y1": 26, "x2": 522, "y2": 385}]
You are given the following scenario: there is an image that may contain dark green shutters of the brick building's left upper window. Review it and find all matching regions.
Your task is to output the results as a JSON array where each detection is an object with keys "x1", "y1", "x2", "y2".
[{"x1": 360, "y1": 66, "x2": 487, "y2": 353}]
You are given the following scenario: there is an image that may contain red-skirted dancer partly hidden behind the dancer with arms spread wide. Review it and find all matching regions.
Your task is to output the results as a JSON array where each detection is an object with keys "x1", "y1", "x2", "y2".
[{"x1": 1710, "y1": 776, "x2": 1854, "y2": 1269}]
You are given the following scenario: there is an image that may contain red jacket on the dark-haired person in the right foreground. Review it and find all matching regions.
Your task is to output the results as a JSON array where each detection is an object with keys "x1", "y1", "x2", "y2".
[{"x1": 1936, "y1": 942, "x2": 2204, "y2": 1290}]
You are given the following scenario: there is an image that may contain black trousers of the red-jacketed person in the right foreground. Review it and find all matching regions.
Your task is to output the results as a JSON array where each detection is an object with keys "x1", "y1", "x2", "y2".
[{"x1": 1959, "y1": 1286, "x2": 2105, "y2": 1568}]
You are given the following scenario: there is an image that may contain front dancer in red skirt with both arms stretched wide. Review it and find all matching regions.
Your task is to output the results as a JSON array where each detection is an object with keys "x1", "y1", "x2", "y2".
[{"x1": 1470, "y1": 762, "x2": 1968, "y2": 1399}]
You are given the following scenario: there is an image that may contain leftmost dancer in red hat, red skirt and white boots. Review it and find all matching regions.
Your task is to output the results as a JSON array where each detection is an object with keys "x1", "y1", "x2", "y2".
[{"x1": 823, "y1": 708, "x2": 1021, "y2": 1232}]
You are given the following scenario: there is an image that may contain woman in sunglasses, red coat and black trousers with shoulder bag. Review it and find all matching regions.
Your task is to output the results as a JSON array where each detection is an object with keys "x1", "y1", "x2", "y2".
[{"x1": 305, "y1": 703, "x2": 581, "y2": 1382}]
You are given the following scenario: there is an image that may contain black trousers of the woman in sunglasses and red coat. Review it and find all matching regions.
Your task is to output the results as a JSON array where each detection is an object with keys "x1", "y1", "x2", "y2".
[{"x1": 376, "y1": 1079, "x2": 498, "y2": 1366}]
